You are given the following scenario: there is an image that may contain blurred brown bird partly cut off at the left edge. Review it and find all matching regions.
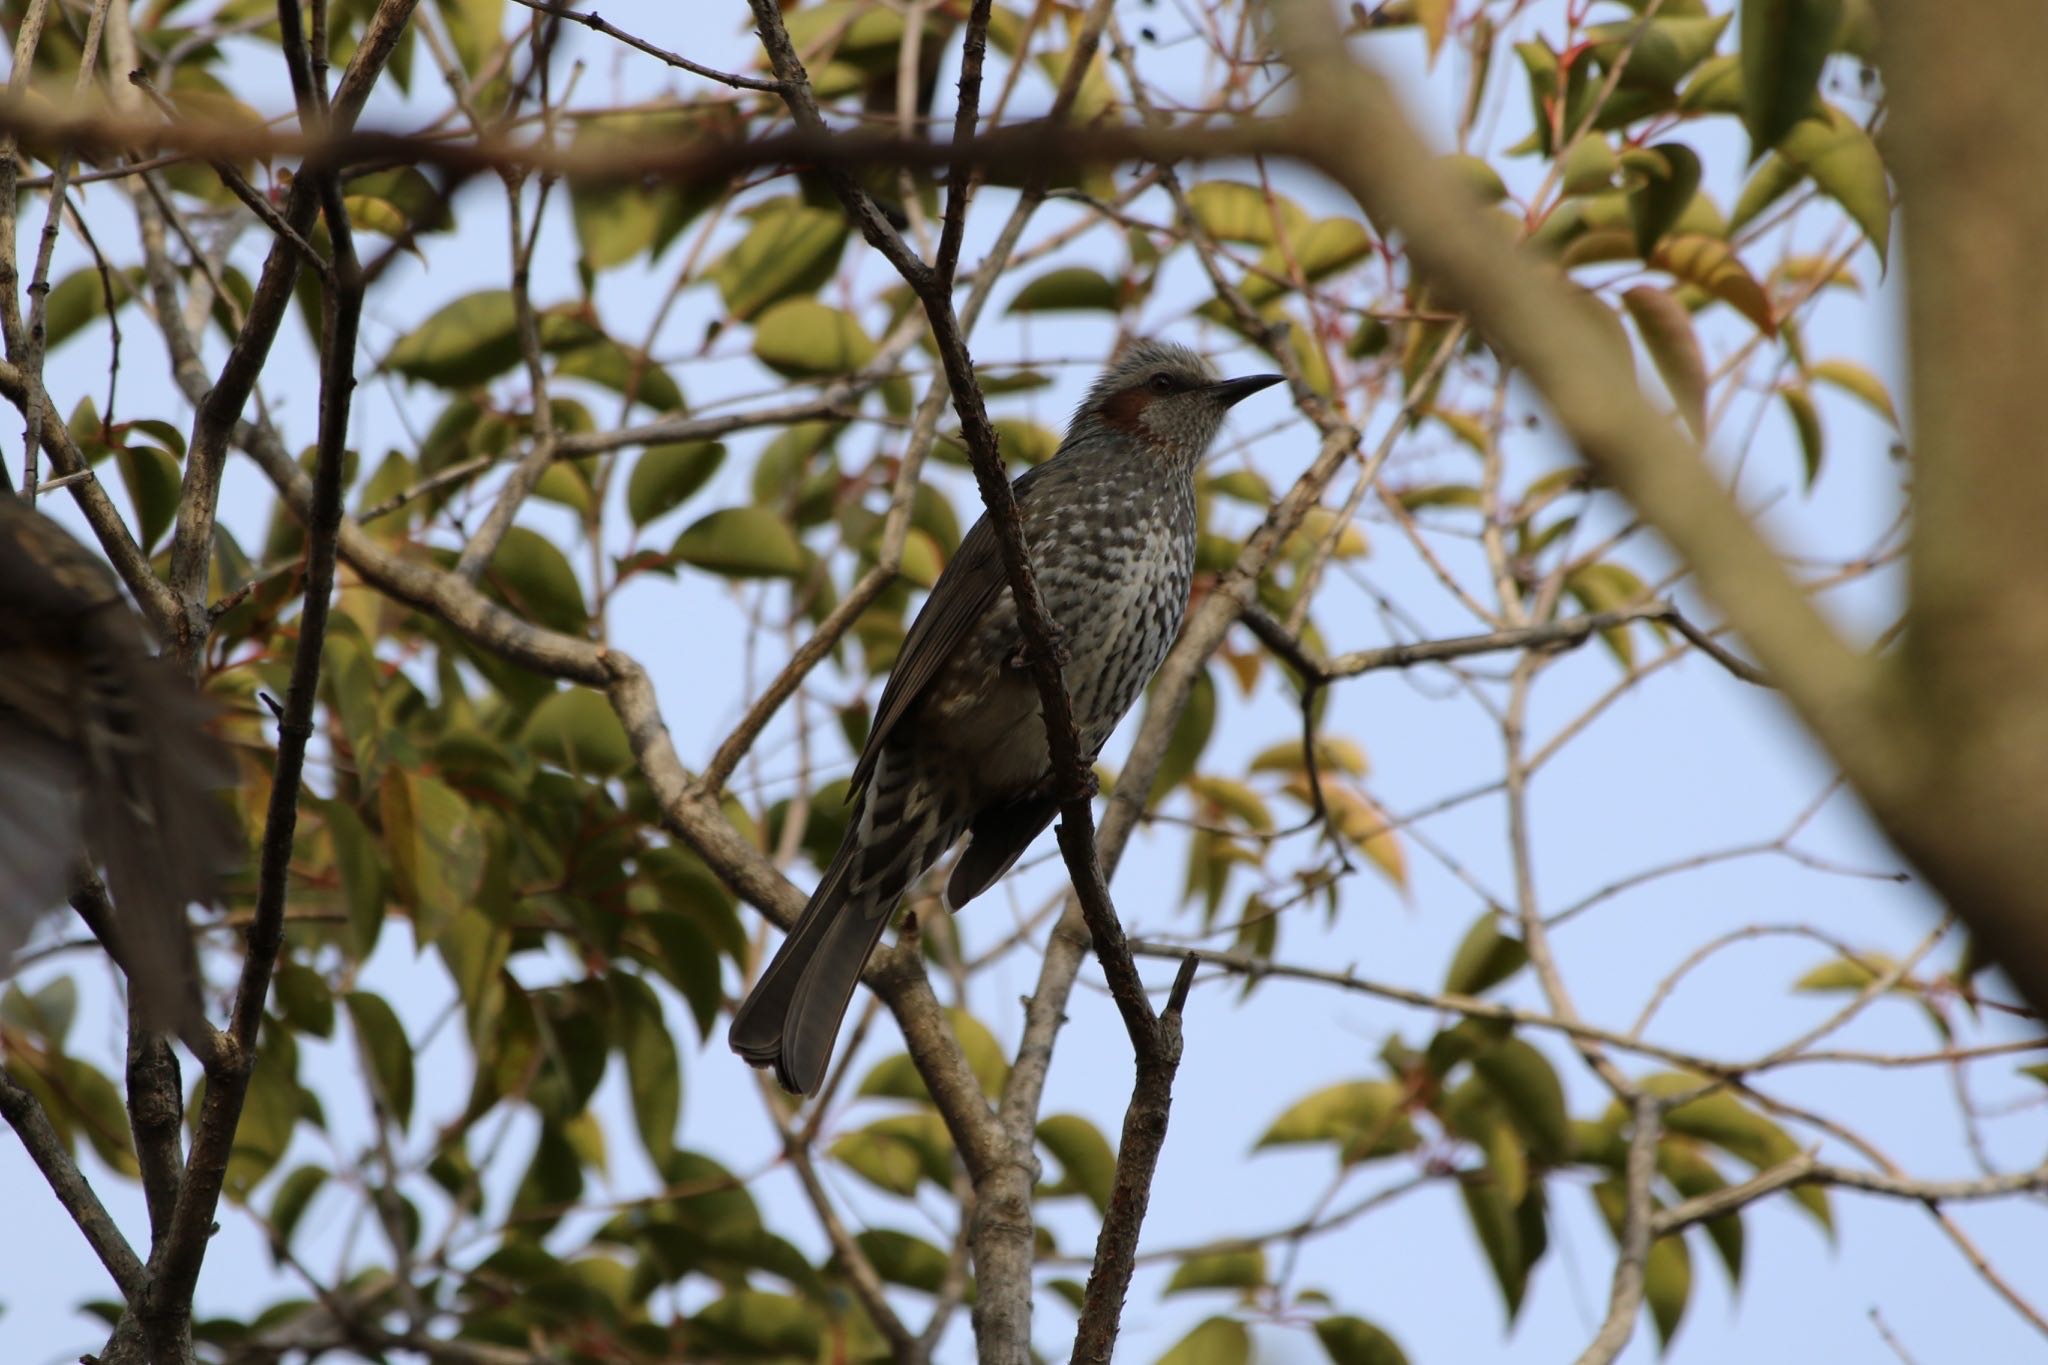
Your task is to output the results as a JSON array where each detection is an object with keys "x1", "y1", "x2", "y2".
[{"x1": 0, "y1": 497, "x2": 242, "y2": 1027}]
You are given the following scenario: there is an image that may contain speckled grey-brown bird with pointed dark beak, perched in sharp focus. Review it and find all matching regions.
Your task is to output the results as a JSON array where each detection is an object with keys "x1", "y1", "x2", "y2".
[{"x1": 729, "y1": 342, "x2": 1280, "y2": 1095}]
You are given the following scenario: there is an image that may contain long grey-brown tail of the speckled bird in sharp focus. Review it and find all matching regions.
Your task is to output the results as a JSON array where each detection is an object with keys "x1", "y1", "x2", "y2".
[{"x1": 727, "y1": 761, "x2": 961, "y2": 1095}]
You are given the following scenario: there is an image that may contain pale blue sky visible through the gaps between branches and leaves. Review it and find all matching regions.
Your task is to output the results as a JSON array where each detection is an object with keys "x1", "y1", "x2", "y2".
[{"x1": 0, "y1": 0, "x2": 2048, "y2": 1365}]
